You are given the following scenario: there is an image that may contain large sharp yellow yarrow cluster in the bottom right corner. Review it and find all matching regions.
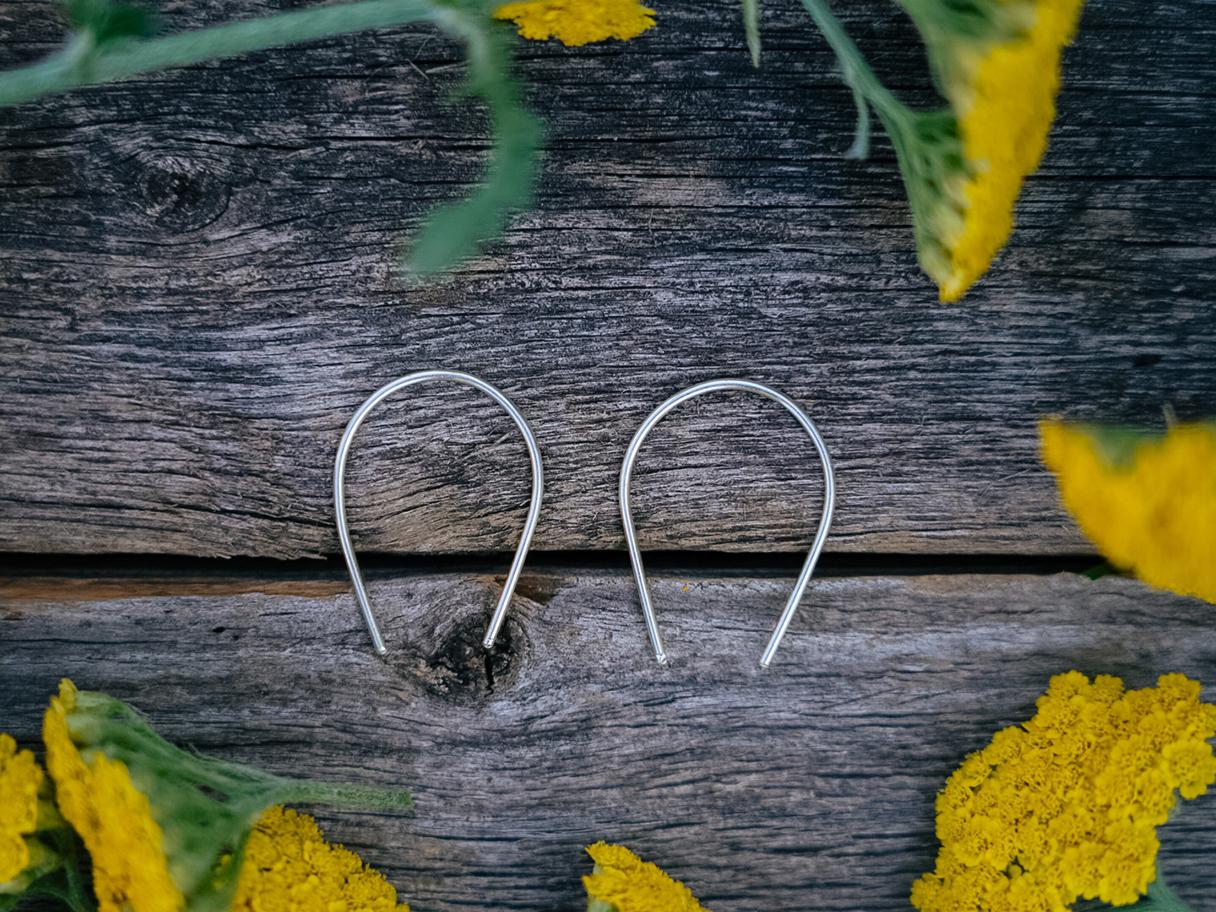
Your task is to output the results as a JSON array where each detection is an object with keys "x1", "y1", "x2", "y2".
[{"x1": 912, "y1": 671, "x2": 1216, "y2": 912}]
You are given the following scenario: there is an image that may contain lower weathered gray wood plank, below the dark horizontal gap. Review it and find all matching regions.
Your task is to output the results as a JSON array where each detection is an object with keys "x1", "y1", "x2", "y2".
[{"x1": 0, "y1": 570, "x2": 1216, "y2": 912}]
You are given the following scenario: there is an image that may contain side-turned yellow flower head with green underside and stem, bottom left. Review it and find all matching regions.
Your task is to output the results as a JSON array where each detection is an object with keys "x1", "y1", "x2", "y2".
[{"x1": 43, "y1": 680, "x2": 410, "y2": 912}]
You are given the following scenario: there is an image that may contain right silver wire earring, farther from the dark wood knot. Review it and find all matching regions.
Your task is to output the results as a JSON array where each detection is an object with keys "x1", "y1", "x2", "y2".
[{"x1": 620, "y1": 379, "x2": 835, "y2": 668}]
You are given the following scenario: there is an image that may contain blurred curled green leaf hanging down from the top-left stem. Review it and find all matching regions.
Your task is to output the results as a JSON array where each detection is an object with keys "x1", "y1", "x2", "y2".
[{"x1": 404, "y1": 9, "x2": 542, "y2": 277}]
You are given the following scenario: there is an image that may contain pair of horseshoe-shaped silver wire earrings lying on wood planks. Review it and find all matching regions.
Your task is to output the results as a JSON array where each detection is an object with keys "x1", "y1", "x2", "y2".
[{"x1": 333, "y1": 371, "x2": 835, "y2": 668}]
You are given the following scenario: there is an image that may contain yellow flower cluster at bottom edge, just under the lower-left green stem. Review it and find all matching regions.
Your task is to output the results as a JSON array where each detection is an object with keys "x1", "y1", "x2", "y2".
[{"x1": 232, "y1": 807, "x2": 410, "y2": 912}]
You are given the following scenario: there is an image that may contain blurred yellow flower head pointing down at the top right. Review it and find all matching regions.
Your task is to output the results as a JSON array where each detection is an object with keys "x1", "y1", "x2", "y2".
[{"x1": 902, "y1": 0, "x2": 1083, "y2": 302}]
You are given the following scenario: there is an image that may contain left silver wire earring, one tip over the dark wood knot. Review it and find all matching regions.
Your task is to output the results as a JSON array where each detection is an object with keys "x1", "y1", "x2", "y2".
[{"x1": 333, "y1": 371, "x2": 545, "y2": 655}]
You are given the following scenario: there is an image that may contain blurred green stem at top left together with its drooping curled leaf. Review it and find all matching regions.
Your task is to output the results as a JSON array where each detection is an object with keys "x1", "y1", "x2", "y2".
[{"x1": 0, "y1": 0, "x2": 541, "y2": 276}]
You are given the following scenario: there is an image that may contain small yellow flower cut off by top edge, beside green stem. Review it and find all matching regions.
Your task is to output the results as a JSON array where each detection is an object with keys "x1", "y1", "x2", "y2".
[{"x1": 494, "y1": 0, "x2": 654, "y2": 47}]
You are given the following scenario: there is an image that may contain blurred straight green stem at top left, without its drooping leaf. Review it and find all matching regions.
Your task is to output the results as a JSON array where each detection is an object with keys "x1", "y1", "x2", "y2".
[{"x1": 0, "y1": 0, "x2": 441, "y2": 107}]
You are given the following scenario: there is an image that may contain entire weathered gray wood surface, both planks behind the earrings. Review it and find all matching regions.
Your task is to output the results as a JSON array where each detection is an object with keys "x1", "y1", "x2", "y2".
[{"x1": 0, "y1": 0, "x2": 1216, "y2": 912}]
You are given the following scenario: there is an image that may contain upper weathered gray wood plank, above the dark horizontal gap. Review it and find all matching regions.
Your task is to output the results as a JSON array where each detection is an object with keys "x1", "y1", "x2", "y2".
[{"x1": 0, "y1": 0, "x2": 1216, "y2": 557}]
